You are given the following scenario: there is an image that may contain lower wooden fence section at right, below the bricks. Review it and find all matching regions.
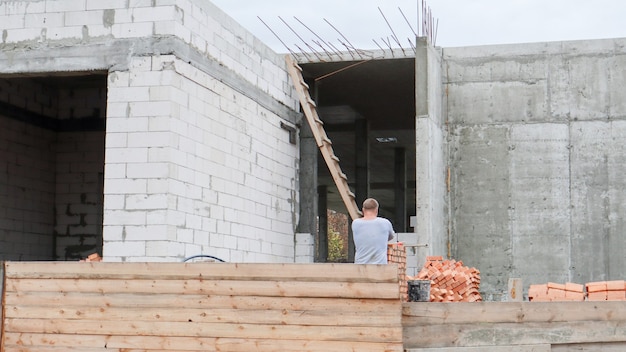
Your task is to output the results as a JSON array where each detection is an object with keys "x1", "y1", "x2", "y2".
[{"x1": 402, "y1": 301, "x2": 626, "y2": 352}]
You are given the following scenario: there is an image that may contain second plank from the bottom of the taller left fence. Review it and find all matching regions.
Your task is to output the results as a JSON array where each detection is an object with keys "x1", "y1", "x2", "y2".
[{"x1": 4, "y1": 318, "x2": 402, "y2": 344}]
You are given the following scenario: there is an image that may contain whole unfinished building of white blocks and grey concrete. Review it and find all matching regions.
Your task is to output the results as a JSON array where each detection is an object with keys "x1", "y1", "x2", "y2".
[{"x1": 0, "y1": 0, "x2": 626, "y2": 301}]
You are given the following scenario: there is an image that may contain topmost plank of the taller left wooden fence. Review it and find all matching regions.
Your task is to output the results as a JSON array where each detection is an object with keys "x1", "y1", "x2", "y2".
[{"x1": 6, "y1": 262, "x2": 398, "y2": 283}]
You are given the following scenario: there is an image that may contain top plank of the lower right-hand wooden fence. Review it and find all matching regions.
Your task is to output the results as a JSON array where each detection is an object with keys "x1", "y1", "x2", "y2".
[{"x1": 402, "y1": 301, "x2": 626, "y2": 326}]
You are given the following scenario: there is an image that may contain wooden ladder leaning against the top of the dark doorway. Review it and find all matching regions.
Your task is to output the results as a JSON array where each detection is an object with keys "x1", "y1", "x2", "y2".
[{"x1": 285, "y1": 55, "x2": 362, "y2": 220}]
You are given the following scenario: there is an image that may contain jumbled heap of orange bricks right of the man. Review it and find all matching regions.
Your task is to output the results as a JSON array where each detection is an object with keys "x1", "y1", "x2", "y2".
[{"x1": 408, "y1": 256, "x2": 482, "y2": 302}]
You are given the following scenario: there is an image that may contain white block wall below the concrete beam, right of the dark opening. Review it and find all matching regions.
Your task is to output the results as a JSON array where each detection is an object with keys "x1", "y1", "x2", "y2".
[{"x1": 104, "y1": 55, "x2": 298, "y2": 262}]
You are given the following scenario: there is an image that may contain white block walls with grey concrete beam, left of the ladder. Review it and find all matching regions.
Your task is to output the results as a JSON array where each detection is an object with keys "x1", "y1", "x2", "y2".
[{"x1": 0, "y1": 0, "x2": 299, "y2": 262}]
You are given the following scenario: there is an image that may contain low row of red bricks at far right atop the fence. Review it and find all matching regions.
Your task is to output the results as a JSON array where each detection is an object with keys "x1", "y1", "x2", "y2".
[{"x1": 528, "y1": 280, "x2": 626, "y2": 302}]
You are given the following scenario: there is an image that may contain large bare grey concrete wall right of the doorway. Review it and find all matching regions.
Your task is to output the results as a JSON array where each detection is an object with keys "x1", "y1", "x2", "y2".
[{"x1": 443, "y1": 39, "x2": 626, "y2": 300}]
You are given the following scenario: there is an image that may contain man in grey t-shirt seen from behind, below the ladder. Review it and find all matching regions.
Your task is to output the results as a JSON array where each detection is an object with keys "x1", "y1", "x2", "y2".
[{"x1": 352, "y1": 198, "x2": 394, "y2": 264}]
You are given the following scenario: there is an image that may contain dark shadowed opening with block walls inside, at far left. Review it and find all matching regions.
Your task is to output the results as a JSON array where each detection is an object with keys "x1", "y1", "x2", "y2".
[{"x1": 0, "y1": 76, "x2": 104, "y2": 260}]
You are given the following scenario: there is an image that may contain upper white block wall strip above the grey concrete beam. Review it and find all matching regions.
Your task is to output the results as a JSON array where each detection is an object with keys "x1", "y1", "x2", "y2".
[{"x1": 0, "y1": 0, "x2": 297, "y2": 109}]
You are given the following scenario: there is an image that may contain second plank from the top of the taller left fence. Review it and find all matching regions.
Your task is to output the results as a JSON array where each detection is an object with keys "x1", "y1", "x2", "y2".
[{"x1": 6, "y1": 273, "x2": 400, "y2": 299}]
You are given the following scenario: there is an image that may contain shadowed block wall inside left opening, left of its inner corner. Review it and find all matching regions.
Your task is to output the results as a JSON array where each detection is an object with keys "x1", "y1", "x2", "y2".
[{"x1": 0, "y1": 116, "x2": 55, "y2": 260}]
